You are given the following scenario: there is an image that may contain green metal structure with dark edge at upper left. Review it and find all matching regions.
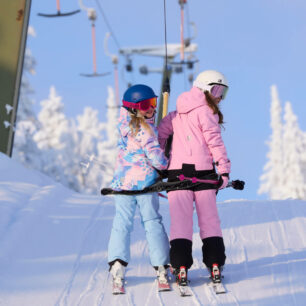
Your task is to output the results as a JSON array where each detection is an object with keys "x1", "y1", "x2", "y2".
[{"x1": 0, "y1": 0, "x2": 31, "y2": 156}]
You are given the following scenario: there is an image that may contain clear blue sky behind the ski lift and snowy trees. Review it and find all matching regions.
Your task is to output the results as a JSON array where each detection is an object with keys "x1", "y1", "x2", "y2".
[{"x1": 28, "y1": 0, "x2": 306, "y2": 200}]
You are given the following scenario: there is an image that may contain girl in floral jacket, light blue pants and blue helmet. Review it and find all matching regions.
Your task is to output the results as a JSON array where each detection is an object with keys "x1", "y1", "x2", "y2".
[{"x1": 108, "y1": 84, "x2": 169, "y2": 286}]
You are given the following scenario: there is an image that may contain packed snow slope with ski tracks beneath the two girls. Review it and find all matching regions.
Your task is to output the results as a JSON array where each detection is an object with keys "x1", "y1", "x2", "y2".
[{"x1": 0, "y1": 154, "x2": 306, "y2": 306}]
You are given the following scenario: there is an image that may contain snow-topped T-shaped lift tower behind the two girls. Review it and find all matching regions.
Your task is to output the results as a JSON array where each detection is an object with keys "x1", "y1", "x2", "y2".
[{"x1": 119, "y1": 44, "x2": 197, "y2": 123}]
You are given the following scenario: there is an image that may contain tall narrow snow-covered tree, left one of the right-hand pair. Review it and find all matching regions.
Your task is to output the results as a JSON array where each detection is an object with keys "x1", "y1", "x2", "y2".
[{"x1": 258, "y1": 85, "x2": 284, "y2": 200}]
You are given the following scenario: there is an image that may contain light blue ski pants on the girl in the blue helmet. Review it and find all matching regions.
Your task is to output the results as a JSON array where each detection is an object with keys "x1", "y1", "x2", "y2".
[{"x1": 108, "y1": 193, "x2": 169, "y2": 266}]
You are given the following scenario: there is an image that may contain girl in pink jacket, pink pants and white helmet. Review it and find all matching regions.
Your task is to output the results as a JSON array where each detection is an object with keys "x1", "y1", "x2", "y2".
[{"x1": 158, "y1": 71, "x2": 231, "y2": 285}]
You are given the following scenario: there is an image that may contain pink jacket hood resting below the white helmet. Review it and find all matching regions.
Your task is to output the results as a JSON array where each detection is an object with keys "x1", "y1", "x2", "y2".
[{"x1": 176, "y1": 87, "x2": 206, "y2": 114}]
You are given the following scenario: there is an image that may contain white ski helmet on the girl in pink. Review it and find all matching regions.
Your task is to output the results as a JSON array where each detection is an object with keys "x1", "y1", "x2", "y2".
[{"x1": 193, "y1": 70, "x2": 228, "y2": 92}]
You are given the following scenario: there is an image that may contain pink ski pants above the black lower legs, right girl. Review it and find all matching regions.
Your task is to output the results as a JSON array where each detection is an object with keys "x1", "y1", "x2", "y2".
[{"x1": 168, "y1": 190, "x2": 222, "y2": 241}]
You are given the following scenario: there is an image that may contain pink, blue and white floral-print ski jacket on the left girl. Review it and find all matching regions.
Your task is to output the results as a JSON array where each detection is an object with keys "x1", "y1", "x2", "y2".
[{"x1": 111, "y1": 107, "x2": 168, "y2": 190}]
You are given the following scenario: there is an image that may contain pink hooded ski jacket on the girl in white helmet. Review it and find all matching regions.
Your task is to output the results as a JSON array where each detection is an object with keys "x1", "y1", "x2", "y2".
[{"x1": 158, "y1": 87, "x2": 231, "y2": 174}]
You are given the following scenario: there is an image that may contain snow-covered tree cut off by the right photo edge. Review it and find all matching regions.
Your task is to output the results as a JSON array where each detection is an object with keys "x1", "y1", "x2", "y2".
[{"x1": 282, "y1": 102, "x2": 306, "y2": 199}]
